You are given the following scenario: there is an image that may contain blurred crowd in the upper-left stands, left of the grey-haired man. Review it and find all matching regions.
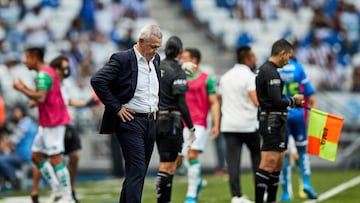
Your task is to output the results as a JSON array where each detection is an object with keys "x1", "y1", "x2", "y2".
[{"x1": 0, "y1": 0, "x2": 148, "y2": 130}]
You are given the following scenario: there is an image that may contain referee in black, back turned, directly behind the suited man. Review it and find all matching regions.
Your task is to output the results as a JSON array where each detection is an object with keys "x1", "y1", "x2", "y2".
[{"x1": 156, "y1": 36, "x2": 195, "y2": 203}]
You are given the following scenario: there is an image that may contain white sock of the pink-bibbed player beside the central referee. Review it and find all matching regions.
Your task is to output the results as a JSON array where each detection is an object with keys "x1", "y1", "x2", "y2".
[{"x1": 186, "y1": 160, "x2": 201, "y2": 197}]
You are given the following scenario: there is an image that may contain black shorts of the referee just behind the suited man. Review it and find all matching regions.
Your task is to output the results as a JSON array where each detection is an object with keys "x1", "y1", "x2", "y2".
[{"x1": 156, "y1": 113, "x2": 184, "y2": 162}]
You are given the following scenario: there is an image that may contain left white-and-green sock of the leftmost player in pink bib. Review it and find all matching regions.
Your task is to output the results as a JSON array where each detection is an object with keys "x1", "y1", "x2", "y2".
[{"x1": 37, "y1": 160, "x2": 61, "y2": 193}]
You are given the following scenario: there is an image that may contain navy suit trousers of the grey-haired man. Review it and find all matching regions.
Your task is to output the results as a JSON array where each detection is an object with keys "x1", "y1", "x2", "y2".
[{"x1": 115, "y1": 115, "x2": 156, "y2": 203}]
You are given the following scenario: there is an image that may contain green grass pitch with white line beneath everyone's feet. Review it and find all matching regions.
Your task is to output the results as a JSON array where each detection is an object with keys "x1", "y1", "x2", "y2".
[{"x1": 0, "y1": 170, "x2": 360, "y2": 203}]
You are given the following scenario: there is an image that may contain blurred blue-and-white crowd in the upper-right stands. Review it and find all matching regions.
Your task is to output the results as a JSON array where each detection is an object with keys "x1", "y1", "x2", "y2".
[{"x1": 182, "y1": 0, "x2": 360, "y2": 92}]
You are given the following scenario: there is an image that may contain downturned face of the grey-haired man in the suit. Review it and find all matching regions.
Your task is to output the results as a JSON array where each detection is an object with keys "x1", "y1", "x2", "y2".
[{"x1": 139, "y1": 36, "x2": 162, "y2": 61}]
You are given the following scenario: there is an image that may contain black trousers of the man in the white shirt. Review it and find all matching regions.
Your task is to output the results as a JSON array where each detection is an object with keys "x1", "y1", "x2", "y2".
[{"x1": 223, "y1": 132, "x2": 261, "y2": 197}]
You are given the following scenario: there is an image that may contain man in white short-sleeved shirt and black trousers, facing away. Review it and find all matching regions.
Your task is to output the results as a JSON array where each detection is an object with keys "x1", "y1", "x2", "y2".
[{"x1": 219, "y1": 46, "x2": 260, "y2": 203}]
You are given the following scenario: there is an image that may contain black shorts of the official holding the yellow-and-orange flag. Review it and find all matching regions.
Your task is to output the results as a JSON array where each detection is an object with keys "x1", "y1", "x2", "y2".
[{"x1": 259, "y1": 114, "x2": 287, "y2": 152}]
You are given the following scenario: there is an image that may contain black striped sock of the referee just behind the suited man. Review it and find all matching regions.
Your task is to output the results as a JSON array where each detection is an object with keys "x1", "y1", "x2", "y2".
[{"x1": 156, "y1": 171, "x2": 173, "y2": 203}]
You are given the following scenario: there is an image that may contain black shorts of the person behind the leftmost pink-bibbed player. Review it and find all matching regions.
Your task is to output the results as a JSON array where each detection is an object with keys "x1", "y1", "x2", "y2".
[{"x1": 64, "y1": 125, "x2": 81, "y2": 155}]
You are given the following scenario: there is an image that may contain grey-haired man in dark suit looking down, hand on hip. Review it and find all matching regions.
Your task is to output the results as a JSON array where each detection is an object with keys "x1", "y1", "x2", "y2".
[{"x1": 91, "y1": 25, "x2": 162, "y2": 203}]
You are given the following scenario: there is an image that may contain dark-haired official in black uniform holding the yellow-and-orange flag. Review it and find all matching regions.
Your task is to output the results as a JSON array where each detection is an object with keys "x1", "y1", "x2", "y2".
[{"x1": 255, "y1": 39, "x2": 304, "y2": 203}]
